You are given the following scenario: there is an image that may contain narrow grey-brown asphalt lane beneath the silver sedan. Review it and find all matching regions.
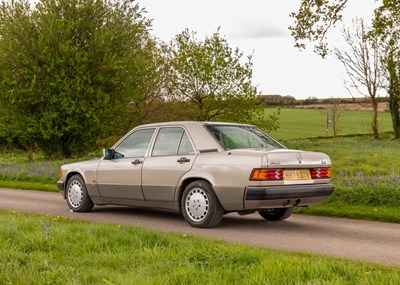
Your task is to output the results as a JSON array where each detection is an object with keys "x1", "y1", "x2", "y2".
[{"x1": 0, "y1": 188, "x2": 400, "y2": 266}]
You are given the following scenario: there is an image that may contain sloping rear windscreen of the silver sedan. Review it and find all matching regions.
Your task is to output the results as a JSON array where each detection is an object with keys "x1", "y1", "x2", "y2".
[{"x1": 206, "y1": 125, "x2": 285, "y2": 150}]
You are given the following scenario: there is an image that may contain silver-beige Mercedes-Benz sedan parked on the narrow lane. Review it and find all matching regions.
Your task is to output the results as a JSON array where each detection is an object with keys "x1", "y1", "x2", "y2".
[{"x1": 57, "y1": 122, "x2": 333, "y2": 227}]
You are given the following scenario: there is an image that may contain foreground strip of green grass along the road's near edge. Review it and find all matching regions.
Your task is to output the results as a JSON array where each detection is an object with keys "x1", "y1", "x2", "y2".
[{"x1": 0, "y1": 211, "x2": 400, "y2": 284}]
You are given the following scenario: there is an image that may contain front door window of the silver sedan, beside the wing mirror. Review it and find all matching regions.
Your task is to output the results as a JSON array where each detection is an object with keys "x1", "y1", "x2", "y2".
[{"x1": 114, "y1": 128, "x2": 154, "y2": 158}]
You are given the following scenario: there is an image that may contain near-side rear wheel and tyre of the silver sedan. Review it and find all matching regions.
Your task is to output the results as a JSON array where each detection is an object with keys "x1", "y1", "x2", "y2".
[{"x1": 181, "y1": 180, "x2": 225, "y2": 228}]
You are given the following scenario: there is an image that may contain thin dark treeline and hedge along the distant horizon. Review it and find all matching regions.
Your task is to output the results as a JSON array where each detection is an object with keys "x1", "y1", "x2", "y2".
[{"x1": 259, "y1": 95, "x2": 389, "y2": 107}]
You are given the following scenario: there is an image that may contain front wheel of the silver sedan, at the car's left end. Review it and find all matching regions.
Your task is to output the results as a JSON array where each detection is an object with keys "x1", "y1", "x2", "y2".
[{"x1": 65, "y1": 175, "x2": 94, "y2": 212}]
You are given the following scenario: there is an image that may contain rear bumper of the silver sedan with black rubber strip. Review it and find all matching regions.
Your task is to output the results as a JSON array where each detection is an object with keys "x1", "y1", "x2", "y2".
[{"x1": 244, "y1": 184, "x2": 334, "y2": 209}]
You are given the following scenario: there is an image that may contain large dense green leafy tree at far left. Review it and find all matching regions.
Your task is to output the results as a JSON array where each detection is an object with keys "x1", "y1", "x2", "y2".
[{"x1": 0, "y1": 0, "x2": 157, "y2": 157}]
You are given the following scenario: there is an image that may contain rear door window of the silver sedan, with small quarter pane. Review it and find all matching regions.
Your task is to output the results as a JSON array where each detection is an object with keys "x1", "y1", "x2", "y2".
[{"x1": 151, "y1": 127, "x2": 195, "y2": 156}]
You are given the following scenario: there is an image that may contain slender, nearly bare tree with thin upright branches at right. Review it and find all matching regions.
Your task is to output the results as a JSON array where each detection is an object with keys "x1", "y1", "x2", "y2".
[{"x1": 335, "y1": 19, "x2": 383, "y2": 138}]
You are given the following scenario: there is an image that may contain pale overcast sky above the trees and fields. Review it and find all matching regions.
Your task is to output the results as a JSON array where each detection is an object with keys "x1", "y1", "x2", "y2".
[{"x1": 138, "y1": 0, "x2": 376, "y2": 99}]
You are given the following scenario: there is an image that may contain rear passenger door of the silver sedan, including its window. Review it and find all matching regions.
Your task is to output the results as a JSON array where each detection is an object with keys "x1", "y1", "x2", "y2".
[{"x1": 142, "y1": 127, "x2": 196, "y2": 202}]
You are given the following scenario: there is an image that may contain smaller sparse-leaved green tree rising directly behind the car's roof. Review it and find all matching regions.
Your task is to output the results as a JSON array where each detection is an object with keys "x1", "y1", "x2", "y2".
[{"x1": 161, "y1": 30, "x2": 278, "y2": 130}]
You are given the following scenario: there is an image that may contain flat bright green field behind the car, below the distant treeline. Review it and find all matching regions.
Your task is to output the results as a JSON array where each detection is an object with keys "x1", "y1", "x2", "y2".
[{"x1": 265, "y1": 108, "x2": 392, "y2": 140}]
